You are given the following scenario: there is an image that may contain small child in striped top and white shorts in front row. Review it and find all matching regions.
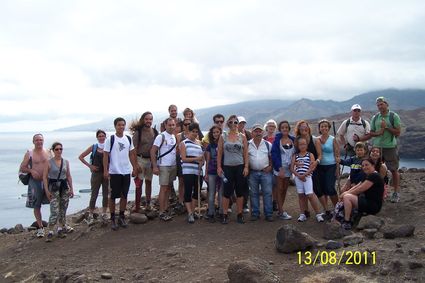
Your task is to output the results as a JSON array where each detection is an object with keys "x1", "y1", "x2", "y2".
[{"x1": 291, "y1": 137, "x2": 325, "y2": 222}]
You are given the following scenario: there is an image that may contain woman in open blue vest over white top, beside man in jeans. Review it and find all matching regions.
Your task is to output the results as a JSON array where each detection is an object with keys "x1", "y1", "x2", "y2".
[{"x1": 271, "y1": 121, "x2": 295, "y2": 220}]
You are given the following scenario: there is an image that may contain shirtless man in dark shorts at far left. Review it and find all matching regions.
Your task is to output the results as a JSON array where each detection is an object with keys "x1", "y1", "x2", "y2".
[{"x1": 20, "y1": 134, "x2": 50, "y2": 238}]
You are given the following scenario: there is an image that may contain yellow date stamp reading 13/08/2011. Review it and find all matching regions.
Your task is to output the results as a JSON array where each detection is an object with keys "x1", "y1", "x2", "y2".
[{"x1": 297, "y1": 250, "x2": 376, "y2": 265}]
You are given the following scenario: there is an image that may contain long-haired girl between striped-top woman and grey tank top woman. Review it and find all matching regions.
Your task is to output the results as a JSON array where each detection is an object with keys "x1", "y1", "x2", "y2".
[{"x1": 205, "y1": 125, "x2": 223, "y2": 223}]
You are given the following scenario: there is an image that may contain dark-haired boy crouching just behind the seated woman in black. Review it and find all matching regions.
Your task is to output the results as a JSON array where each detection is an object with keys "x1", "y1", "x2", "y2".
[{"x1": 340, "y1": 142, "x2": 367, "y2": 193}]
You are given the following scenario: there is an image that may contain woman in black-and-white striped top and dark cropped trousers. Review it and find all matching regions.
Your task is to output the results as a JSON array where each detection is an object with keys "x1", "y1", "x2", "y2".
[{"x1": 179, "y1": 123, "x2": 204, "y2": 224}]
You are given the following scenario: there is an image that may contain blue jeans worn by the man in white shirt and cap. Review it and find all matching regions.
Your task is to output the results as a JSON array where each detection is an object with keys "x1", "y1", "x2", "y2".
[{"x1": 248, "y1": 170, "x2": 273, "y2": 217}]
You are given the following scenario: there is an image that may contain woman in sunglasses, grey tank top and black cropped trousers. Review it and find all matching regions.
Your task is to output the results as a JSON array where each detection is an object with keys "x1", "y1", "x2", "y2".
[{"x1": 217, "y1": 115, "x2": 249, "y2": 224}]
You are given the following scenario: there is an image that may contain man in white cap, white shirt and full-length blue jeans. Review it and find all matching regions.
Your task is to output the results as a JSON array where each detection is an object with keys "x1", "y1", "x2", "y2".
[{"x1": 248, "y1": 124, "x2": 273, "y2": 222}]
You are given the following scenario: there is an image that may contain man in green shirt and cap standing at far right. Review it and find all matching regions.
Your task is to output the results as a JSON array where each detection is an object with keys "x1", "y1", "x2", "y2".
[{"x1": 370, "y1": 96, "x2": 401, "y2": 202}]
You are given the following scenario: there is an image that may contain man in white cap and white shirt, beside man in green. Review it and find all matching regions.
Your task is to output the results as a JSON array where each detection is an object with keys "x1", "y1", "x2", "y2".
[{"x1": 337, "y1": 104, "x2": 370, "y2": 157}]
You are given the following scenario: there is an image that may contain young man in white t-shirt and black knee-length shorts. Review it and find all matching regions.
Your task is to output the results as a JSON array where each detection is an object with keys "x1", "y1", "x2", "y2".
[{"x1": 103, "y1": 117, "x2": 137, "y2": 231}]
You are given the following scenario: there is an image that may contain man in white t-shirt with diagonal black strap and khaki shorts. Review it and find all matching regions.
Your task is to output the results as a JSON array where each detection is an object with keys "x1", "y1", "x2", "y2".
[{"x1": 151, "y1": 118, "x2": 177, "y2": 221}]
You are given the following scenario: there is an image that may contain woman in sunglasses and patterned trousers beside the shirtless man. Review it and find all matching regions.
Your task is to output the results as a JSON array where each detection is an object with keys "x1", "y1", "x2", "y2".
[{"x1": 43, "y1": 142, "x2": 74, "y2": 242}]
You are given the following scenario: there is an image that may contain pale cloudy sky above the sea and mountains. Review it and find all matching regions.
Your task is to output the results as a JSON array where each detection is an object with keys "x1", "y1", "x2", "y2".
[{"x1": 0, "y1": 0, "x2": 425, "y2": 132}]
